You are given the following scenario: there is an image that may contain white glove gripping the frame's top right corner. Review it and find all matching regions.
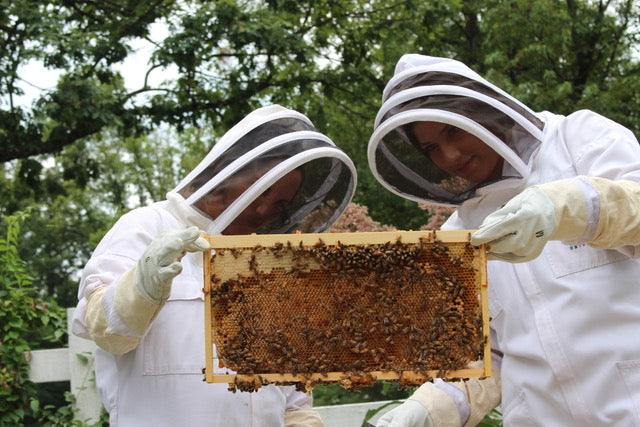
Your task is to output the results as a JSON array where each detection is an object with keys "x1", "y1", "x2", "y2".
[{"x1": 470, "y1": 187, "x2": 557, "y2": 262}]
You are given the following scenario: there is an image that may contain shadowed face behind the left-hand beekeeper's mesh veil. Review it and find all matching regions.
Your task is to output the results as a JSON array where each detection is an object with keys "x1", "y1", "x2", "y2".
[{"x1": 195, "y1": 170, "x2": 302, "y2": 235}]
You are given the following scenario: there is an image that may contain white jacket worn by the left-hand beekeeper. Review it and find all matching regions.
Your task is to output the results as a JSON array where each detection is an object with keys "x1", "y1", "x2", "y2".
[{"x1": 74, "y1": 201, "x2": 312, "y2": 427}]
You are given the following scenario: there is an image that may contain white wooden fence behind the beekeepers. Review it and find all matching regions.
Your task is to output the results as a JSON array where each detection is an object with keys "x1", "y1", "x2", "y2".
[{"x1": 26, "y1": 308, "x2": 404, "y2": 427}]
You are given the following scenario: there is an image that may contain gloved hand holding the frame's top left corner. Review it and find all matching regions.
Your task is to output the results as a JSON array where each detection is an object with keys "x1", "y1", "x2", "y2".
[{"x1": 136, "y1": 227, "x2": 210, "y2": 304}]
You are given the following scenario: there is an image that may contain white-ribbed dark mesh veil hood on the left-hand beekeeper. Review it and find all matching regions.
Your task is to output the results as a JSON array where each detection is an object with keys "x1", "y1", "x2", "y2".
[{"x1": 168, "y1": 105, "x2": 356, "y2": 235}]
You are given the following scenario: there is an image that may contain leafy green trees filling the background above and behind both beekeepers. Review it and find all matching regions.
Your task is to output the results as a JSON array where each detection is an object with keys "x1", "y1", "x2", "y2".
[{"x1": 0, "y1": 0, "x2": 640, "y2": 301}]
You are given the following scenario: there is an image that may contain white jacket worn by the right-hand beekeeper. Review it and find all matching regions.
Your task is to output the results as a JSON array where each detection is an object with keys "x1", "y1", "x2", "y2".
[{"x1": 434, "y1": 111, "x2": 640, "y2": 427}]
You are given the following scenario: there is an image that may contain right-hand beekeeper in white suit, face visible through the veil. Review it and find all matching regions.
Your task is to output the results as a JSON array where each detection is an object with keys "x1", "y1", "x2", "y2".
[{"x1": 368, "y1": 54, "x2": 640, "y2": 426}]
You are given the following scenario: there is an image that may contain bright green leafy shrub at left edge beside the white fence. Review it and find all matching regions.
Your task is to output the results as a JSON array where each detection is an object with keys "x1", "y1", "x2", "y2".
[{"x1": 0, "y1": 213, "x2": 66, "y2": 425}]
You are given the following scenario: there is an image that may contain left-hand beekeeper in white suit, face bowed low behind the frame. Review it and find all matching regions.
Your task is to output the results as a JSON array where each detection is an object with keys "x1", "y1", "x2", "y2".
[{"x1": 73, "y1": 105, "x2": 356, "y2": 427}]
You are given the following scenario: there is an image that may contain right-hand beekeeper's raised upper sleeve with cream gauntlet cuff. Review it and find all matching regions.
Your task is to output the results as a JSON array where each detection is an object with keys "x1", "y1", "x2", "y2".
[{"x1": 539, "y1": 110, "x2": 640, "y2": 257}]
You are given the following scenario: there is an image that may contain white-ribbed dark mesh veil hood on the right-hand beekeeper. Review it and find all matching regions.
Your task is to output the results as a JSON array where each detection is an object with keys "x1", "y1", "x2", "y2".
[{"x1": 368, "y1": 55, "x2": 543, "y2": 206}]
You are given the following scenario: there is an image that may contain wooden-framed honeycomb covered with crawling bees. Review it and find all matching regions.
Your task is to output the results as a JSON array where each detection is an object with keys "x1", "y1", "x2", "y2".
[{"x1": 204, "y1": 231, "x2": 490, "y2": 391}]
